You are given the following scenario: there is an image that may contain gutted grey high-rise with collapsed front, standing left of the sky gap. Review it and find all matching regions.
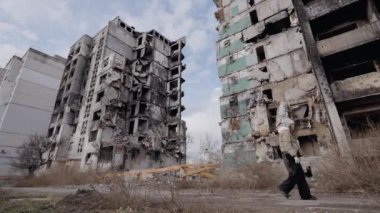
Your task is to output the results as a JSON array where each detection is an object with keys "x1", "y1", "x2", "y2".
[{"x1": 47, "y1": 17, "x2": 186, "y2": 171}]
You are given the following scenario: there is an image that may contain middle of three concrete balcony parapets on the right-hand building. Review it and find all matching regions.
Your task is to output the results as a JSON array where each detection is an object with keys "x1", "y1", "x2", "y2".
[{"x1": 317, "y1": 21, "x2": 380, "y2": 57}]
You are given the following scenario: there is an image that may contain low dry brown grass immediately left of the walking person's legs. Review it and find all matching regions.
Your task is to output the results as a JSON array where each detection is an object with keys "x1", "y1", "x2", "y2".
[{"x1": 177, "y1": 162, "x2": 286, "y2": 190}]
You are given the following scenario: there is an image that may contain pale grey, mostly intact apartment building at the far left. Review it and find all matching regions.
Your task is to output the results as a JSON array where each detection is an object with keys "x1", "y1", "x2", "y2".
[{"x1": 0, "y1": 49, "x2": 65, "y2": 176}]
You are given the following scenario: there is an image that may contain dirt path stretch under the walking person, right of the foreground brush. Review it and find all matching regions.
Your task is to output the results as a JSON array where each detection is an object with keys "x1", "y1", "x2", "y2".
[{"x1": 180, "y1": 190, "x2": 380, "y2": 212}]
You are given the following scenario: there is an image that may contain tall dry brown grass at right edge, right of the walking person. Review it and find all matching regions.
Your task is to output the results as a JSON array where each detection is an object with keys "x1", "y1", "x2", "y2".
[{"x1": 318, "y1": 143, "x2": 380, "y2": 193}]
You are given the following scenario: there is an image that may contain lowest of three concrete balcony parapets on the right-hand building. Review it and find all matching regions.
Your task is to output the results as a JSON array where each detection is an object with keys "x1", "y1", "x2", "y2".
[{"x1": 331, "y1": 72, "x2": 380, "y2": 102}]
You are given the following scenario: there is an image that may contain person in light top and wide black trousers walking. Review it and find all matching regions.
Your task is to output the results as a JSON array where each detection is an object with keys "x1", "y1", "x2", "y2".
[{"x1": 277, "y1": 103, "x2": 316, "y2": 200}]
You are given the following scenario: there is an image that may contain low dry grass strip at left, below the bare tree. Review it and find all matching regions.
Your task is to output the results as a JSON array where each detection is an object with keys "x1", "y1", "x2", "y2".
[{"x1": 13, "y1": 169, "x2": 99, "y2": 187}]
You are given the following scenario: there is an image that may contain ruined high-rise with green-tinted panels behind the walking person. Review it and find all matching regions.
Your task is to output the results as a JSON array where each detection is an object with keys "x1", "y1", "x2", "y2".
[{"x1": 214, "y1": 0, "x2": 380, "y2": 164}]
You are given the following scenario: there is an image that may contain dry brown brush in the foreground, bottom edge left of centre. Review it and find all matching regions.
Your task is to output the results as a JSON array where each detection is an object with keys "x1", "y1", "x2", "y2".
[{"x1": 53, "y1": 177, "x2": 181, "y2": 212}]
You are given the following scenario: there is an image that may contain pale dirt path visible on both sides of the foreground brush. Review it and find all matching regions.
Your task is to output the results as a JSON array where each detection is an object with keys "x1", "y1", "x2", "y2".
[{"x1": 3, "y1": 187, "x2": 380, "y2": 213}]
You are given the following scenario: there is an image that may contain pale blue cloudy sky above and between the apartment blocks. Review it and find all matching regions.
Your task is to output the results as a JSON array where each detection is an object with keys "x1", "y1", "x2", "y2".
[{"x1": 0, "y1": 0, "x2": 221, "y2": 161}]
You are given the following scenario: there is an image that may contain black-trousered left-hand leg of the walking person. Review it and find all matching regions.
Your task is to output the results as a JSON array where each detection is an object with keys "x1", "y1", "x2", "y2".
[{"x1": 279, "y1": 153, "x2": 297, "y2": 194}]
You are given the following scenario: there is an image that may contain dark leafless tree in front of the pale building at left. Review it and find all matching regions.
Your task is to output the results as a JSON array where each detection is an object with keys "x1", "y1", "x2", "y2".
[{"x1": 11, "y1": 135, "x2": 52, "y2": 176}]
